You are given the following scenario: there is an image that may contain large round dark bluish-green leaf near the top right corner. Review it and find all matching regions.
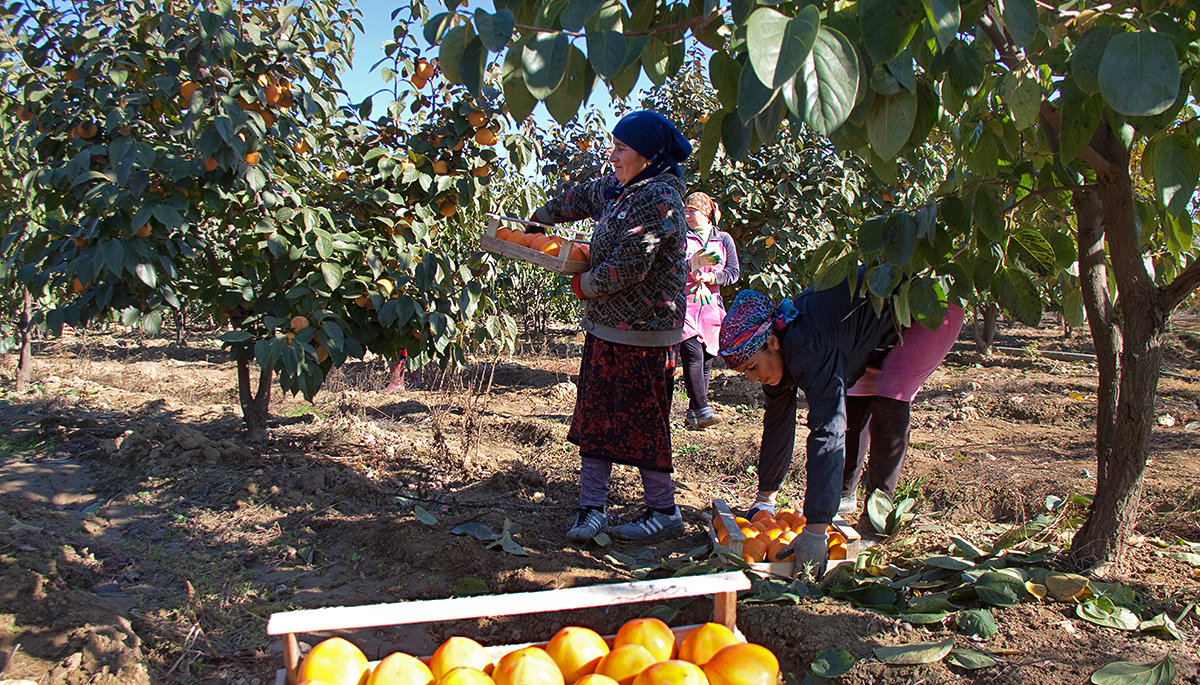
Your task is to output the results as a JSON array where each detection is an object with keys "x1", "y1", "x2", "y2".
[{"x1": 1099, "y1": 31, "x2": 1180, "y2": 116}]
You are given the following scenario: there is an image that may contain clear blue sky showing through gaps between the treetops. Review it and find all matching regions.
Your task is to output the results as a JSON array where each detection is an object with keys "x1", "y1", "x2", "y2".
[{"x1": 342, "y1": 0, "x2": 650, "y2": 127}]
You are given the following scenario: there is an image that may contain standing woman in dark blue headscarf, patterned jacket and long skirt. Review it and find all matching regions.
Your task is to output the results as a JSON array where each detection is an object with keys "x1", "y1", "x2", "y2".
[{"x1": 533, "y1": 112, "x2": 691, "y2": 542}]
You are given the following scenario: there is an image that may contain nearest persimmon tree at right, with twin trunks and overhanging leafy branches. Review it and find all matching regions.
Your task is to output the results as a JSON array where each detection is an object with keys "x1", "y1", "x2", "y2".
[{"x1": 425, "y1": 0, "x2": 1200, "y2": 565}]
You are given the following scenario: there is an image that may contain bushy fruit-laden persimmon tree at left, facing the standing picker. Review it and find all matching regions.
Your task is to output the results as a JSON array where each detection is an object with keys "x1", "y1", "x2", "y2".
[{"x1": 0, "y1": 0, "x2": 515, "y2": 439}]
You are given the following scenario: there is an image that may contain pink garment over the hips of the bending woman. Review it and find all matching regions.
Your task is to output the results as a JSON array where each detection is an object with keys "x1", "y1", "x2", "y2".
[{"x1": 849, "y1": 305, "x2": 964, "y2": 402}]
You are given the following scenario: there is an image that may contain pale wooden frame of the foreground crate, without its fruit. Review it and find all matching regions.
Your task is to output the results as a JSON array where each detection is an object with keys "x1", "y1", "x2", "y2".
[{"x1": 266, "y1": 571, "x2": 750, "y2": 685}]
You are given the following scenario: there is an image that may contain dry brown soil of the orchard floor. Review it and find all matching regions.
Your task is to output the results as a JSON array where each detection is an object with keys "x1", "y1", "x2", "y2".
[{"x1": 0, "y1": 313, "x2": 1200, "y2": 685}]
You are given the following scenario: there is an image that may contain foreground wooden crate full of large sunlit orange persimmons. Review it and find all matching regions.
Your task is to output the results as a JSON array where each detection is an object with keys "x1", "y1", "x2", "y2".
[{"x1": 268, "y1": 572, "x2": 780, "y2": 685}]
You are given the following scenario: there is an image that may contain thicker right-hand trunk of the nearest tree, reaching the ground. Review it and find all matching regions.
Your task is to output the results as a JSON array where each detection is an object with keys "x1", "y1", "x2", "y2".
[{"x1": 1070, "y1": 122, "x2": 1170, "y2": 569}]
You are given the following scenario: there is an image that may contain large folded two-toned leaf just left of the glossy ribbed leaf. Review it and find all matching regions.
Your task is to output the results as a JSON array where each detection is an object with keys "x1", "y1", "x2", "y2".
[{"x1": 746, "y1": 5, "x2": 821, "y2": 89}]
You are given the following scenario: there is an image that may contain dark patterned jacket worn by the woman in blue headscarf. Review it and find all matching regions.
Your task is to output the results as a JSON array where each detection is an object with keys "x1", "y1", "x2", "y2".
[{"x1": 538, "y1": 174, "x2": 688, "y2": 347}]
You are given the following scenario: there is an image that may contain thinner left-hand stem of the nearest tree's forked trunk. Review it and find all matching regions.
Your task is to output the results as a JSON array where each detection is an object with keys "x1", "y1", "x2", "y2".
[{"x1": 1070, "y1": 191, "x2": 1121, "y2": 473}]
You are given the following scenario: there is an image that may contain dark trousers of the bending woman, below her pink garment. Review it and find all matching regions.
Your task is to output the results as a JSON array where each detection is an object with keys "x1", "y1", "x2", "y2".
[{"x1": 841, "y1": 396, "x2": 912, "y2": 497}]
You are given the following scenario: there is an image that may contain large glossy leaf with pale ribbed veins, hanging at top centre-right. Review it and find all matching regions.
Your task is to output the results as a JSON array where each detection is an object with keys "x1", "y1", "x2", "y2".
[{"x1": 784, "y1": 26, "x2": 858, "y2": 136}]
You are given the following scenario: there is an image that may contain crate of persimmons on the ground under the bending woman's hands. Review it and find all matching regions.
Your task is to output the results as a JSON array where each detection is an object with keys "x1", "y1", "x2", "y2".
[{"x1": 708, "y1": 499, "x2": 863, "y2": 576}]
